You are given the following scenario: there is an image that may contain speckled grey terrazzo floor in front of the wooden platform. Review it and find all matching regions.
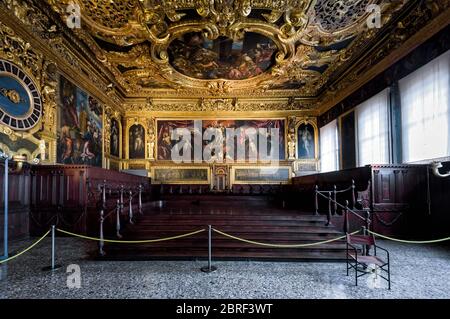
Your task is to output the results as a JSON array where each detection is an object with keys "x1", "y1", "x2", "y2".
[{"x1": 0, "y1": 238, "x2": 450, "y2": 299}]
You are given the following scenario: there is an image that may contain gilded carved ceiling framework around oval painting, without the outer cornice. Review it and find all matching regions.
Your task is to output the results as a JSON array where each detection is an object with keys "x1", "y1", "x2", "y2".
[{"x1": 43, "y1": 0, "x2": 404, "y2": 98}]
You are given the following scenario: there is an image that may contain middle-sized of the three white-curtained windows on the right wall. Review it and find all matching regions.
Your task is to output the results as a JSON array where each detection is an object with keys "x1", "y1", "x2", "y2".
[{"x1": 356, "y1": 89, "x2": 389, "y2": 166}]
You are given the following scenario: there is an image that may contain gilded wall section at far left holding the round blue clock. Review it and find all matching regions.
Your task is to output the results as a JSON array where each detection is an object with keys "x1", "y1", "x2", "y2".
[{"x1": 0, "y1": 22, "x2": 56, "y2": 163}]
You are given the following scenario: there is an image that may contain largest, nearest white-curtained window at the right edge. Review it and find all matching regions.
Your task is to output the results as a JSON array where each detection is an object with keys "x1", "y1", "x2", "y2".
[{"x1": 399, "y1": 51, "x2": 450, "y2": 163}]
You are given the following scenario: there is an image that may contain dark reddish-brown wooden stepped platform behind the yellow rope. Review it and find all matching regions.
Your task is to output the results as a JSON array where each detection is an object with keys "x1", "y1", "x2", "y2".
[{"x1": 102, "y1": 195, "x2": 345, "y2": 260}]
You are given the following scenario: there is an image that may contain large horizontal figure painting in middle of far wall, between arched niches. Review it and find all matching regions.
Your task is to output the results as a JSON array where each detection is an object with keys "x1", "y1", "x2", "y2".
[{"x1": 157, "y1": 119, "x2": 285, "y2": 161}]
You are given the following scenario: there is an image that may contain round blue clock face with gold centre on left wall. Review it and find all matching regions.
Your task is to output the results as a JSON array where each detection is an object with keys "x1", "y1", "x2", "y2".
[{"x1": 0, "y1": 60, "x2": 42, "y2": 130}]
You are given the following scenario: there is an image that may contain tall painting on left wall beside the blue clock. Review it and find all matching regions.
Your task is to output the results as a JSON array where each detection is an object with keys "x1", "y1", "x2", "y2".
[{"x1": 57, "y1": 76, "x2": 103, "y2": 167}]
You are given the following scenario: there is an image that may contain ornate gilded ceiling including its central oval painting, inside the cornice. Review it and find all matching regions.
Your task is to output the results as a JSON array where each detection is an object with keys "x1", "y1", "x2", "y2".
[{"x1": 42, "y1": 0, "x2": 407, "y2": 98}]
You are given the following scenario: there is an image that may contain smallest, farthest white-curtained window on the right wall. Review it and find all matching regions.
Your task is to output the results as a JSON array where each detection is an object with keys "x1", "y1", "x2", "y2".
[{"x1": 320, "y1": 120, "x2": 339, "y2": 172}]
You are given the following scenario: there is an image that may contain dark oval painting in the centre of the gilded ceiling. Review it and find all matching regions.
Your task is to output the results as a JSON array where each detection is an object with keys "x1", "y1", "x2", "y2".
[{"x1": 168, "y1": 32, "x2": 278, "y2": 80}]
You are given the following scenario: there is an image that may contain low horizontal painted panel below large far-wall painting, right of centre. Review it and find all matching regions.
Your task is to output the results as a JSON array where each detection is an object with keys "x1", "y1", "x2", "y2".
[{"x1": 234, "y1": 167, "x2": 291, "y2": 184}]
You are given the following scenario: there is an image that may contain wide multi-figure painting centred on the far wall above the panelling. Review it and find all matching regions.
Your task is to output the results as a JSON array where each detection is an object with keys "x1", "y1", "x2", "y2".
[{"x1": 157, "y1": 119, "x2": 285, "y2": 161}]
